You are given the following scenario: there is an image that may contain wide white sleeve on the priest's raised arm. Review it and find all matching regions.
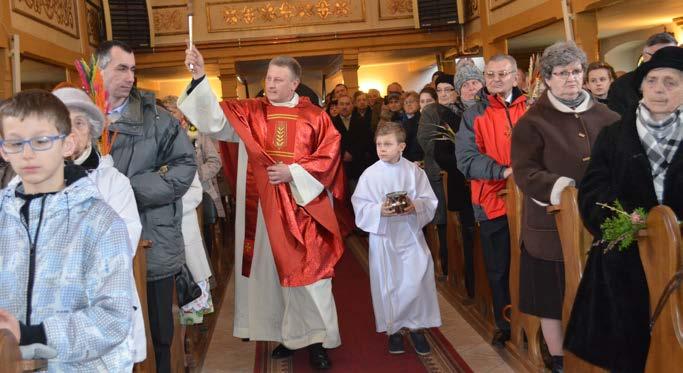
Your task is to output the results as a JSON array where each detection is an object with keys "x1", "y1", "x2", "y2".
[{"x1": 177, "y1": 77, "x2": 239, "y2": 142}]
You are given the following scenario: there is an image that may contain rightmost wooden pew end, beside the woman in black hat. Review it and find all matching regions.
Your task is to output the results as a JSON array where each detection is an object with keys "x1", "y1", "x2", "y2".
[{"x1": 638, "y1": 206, "x2": 683, "y2": 373}]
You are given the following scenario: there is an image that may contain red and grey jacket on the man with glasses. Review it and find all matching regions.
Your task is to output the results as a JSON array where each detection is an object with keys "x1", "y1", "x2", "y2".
[{"x1": 455, "y1": 87, "x2": 526, "y2": 221}]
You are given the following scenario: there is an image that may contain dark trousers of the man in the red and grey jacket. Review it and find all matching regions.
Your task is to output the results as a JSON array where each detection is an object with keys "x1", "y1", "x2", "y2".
[{"x1": 479, "y1": 216, "x2": 510, "y2": 330}]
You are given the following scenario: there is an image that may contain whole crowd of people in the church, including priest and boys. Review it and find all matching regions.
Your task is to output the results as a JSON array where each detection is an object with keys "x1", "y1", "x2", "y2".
[{"x1": 0, "y1": 33, "x2": 683, "y2": 372}]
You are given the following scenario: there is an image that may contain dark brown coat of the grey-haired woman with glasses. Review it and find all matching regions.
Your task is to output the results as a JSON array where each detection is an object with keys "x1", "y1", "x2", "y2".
[{"x1": 511, "y1": 91, "x2": 619, "y2": 261}]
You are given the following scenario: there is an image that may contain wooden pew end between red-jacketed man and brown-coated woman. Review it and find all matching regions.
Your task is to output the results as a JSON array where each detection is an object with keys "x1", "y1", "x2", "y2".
[{"x1": 498, "y1": 177, "x2": 545, "y2": 371}]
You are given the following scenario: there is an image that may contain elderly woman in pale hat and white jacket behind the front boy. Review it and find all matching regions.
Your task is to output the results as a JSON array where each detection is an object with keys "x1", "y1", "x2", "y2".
[{"x1": 52, "y1": 88, "x2": 147, "y2": 362}]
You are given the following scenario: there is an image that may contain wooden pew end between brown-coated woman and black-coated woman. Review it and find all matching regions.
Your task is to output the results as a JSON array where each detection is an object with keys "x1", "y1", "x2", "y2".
[{"x1": 548, "y1": 187, "x2": 605, "y2": 373}]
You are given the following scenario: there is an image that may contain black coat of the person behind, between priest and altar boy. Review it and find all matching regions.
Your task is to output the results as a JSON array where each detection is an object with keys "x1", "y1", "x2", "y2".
[{"x1": 332, "y1": 113, "x2": 377, "y2": 179}]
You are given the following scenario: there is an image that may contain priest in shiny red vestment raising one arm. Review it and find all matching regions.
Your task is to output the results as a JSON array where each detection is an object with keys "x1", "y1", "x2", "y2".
[{"x1": 178, "y1": 46, "x2": 345, "y2": 369}]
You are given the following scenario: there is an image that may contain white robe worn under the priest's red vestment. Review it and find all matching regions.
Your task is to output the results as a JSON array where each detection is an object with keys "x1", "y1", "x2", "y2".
[{"x1": 178, "y1": 78, "x2": 341, "y2": 349}]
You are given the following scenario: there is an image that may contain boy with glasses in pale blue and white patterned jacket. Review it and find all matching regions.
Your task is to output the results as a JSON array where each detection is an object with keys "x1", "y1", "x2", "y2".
[{"x1": 0, "y1": 90, "x2": 135, "y2": 372}]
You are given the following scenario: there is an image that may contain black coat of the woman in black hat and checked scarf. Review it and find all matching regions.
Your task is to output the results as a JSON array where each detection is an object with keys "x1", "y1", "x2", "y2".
[{"x1": 565, "y1": 112, "x2": 683, "y2": 371}]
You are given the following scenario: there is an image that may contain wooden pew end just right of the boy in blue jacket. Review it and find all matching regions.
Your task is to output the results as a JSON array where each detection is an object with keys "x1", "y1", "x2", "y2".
[{"x1": 133, "y1": 240, "x2": 157, "y2": 373}]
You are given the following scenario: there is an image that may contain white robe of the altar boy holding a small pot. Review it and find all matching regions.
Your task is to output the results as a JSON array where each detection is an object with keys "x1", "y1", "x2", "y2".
[{"x1": 351, "y1": 158, "x2": 441, "y2": 334}]
